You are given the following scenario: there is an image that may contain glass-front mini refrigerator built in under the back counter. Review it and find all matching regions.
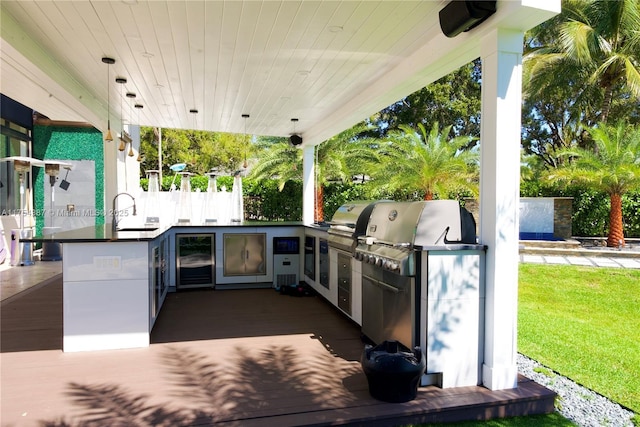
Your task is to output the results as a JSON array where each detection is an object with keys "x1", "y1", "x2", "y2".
[{"x1": 176, "y1": 234, "x2": 215, "y2": 290}]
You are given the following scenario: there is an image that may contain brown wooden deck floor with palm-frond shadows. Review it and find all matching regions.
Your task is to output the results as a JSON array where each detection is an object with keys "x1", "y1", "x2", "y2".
[{"x1": 0, "y1": 276, "x2": 555, "y2": 427}]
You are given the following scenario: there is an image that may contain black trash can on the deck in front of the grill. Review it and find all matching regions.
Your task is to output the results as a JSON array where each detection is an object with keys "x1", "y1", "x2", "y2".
[{"x1": 361, "y1": 341, "x2": 426, "y2": 403}]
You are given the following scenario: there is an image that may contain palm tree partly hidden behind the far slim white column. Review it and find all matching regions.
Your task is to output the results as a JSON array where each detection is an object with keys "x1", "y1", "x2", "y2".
[{"x1": 251, "y1": 123, "x2": 376, "y2": 222}]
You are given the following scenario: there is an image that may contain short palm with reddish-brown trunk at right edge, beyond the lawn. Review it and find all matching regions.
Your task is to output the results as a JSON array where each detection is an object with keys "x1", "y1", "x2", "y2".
[{"x1": 549, "y1": 122, "x2": 640, "y2": 247}]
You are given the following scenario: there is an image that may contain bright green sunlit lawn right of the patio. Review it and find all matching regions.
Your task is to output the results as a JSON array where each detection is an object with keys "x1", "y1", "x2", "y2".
[{"x1": 518, "y1": 264, "x2": 640, "y2": 413}]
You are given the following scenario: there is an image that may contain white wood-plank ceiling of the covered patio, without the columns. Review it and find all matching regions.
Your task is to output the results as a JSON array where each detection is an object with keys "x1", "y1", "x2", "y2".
[{"x1": 0, "y1": 0, "x2": 559, "y2": 145}]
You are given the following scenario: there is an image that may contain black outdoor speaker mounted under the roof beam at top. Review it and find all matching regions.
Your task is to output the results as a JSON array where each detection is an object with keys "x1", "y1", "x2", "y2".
[{"x1": 439, "y1": 0, "x2": 496, "y2": 37}]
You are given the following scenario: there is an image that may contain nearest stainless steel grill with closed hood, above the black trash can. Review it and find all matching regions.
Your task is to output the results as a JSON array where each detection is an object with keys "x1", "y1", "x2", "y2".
[{"x1": 354, "y1": 200, "x2": 475, "y2": 347}]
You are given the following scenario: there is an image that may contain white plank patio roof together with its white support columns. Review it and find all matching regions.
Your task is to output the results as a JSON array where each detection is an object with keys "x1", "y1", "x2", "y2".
[{"x1": 0, "y1": 0, "x2": 560, "y2": 398}]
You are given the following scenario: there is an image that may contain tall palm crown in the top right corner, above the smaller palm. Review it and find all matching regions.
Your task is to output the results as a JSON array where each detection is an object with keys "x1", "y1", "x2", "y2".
[{"x1": 524, "y1": 0, "x2": 640, "y2": 125}]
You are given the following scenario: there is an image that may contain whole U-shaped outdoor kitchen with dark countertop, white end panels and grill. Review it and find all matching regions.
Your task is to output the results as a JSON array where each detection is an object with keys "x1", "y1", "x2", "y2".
[{"x1": 27, "y1": 207, "x2": 485, "y2": 388}]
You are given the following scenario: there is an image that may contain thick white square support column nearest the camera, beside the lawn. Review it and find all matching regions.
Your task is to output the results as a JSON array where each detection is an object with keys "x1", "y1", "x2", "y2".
[{"x1": 480, "y1": 29, "x2": 523, "y2": 390}]
